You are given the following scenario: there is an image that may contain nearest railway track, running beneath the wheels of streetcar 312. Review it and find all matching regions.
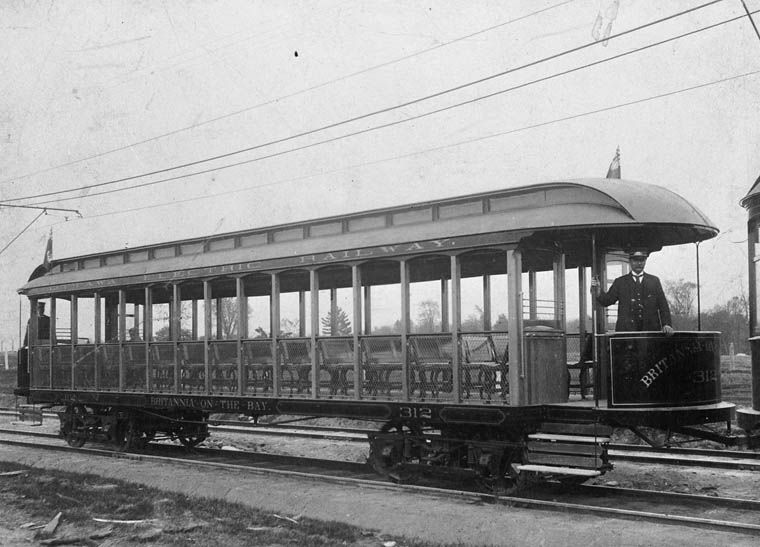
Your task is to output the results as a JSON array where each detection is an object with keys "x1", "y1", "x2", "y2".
[{"x1": 0, "y1": 430, "x2": 760, "y2": 535}]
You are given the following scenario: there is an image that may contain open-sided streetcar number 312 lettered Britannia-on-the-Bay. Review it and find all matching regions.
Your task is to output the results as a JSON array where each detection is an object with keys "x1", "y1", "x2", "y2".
[{"x1": 14, "y1": 179, "x2": 733, "y2": 488}]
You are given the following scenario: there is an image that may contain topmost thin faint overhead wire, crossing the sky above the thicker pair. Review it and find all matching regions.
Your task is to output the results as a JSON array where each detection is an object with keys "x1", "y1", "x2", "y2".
[{"x1": 0, "y1": 0, "x2": 575, "y2": 184}]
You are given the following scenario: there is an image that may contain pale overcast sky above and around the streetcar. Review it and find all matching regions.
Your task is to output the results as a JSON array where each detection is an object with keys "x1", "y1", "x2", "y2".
[{"x1": 0, "y1": 0, "x2": 760, "y2": 347}]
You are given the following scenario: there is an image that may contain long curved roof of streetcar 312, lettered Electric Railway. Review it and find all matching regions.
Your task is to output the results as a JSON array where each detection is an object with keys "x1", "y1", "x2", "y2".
[{"x1": 19, "y1": 179, "x2": 718, "y2": 294}]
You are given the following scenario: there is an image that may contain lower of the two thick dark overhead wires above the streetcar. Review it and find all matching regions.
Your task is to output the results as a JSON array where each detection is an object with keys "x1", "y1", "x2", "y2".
[{"x1": 32, "y1": 7, "x2": 756, "y2": 206}]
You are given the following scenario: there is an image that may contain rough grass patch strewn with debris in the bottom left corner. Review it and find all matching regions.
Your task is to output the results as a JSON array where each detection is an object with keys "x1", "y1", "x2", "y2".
[{"x1": 0, "y1": 462, "x2": 454, "y2": 547}]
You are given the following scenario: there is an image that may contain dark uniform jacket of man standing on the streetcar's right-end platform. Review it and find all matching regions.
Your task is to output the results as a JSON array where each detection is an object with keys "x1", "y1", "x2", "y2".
[{"x1": 596, "y1": 273, "x2": 670, "y2": 331}]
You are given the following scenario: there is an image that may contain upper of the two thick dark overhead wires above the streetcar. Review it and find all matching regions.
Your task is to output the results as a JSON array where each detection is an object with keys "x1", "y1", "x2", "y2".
[{"x1": 0, "y1": 0, "x2": 722, "y2": 203}]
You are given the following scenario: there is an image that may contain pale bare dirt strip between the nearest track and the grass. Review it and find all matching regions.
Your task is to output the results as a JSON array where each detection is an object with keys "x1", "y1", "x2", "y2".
[{"x1": 0, "y1": 446, "x2": 758, "y2": 547}]
